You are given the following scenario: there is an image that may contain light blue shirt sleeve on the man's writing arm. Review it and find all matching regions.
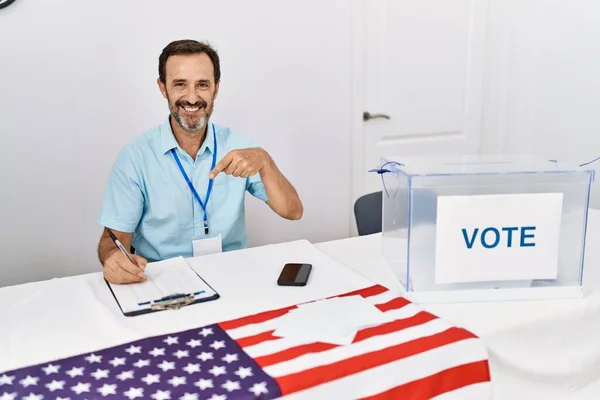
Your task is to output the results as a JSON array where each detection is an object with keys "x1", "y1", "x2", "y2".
[{"x1": 98, "y1": 148, "x2": 144, "y2": 232}]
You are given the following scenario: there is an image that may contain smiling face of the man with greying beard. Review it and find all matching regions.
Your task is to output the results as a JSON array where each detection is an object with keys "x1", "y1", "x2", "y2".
[{"x1": 158, "y1": 53, "x2": 219, "y2": 133}]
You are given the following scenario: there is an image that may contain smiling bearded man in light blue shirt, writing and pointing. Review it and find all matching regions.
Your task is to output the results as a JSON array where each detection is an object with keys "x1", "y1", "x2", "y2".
[{"x1": 98, "y1": 40, "x2": 303, "y2": 283}]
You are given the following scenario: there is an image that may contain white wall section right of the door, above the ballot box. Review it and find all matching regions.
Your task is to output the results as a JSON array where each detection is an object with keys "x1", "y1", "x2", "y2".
[{"x1": 483, "y1": 0, "x2": 600, "y2": 208}]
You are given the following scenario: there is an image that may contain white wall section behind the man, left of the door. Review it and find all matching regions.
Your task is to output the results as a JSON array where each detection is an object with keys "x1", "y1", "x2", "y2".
[{"x1": 0, "y1": 0, "x2": 352, "y2": 286}]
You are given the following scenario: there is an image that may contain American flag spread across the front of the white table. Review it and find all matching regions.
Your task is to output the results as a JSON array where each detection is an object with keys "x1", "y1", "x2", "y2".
[{"x1": 0, "y1": 285, "x2": 491, "y2": 400}]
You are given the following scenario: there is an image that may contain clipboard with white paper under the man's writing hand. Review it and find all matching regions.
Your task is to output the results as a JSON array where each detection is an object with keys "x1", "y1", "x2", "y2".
[{"x1": 104, "y1": 257, "x2": 220, "y2": 317}]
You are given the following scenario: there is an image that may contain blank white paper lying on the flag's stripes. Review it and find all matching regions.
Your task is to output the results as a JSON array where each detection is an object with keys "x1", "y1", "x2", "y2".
[{"x1": 273, "y1": 296, "x2": 393, "y2": 345}]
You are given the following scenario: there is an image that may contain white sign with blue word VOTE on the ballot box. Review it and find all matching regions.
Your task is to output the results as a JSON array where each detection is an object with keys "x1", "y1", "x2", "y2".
[{"x1": 435, "y1": 193, "x2": 563, "y2": 284}]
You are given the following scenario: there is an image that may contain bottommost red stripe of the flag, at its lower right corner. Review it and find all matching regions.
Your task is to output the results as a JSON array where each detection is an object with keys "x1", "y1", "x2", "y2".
[{"x1": 361, "y1": 360, "x2": 490, "y2": 400}]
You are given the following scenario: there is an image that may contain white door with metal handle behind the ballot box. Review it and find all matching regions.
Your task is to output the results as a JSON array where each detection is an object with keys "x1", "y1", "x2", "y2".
[{"x1": 353, "y1": 0, "x2": 488, "y2": 200}]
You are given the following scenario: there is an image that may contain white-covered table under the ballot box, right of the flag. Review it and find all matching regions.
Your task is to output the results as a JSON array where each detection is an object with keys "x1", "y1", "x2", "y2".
[{"x1": 317, "y1": 210, "x2": 600, "y2": 400}]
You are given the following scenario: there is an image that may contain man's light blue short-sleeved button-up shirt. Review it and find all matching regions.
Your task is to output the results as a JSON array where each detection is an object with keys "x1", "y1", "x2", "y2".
[{"x1": 98, "y1": 118, "x2": 267, "y2": 262}]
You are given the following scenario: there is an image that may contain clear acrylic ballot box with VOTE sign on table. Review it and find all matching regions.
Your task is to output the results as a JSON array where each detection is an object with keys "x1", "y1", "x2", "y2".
[{"x1": 377, "y1": 156, "x2": 594, "y2": 303}]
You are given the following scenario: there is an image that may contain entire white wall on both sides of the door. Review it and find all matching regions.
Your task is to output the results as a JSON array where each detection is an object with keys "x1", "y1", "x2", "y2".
[{"x1": 0, "y1": 0, "x2": 600, "y2": 286}]
